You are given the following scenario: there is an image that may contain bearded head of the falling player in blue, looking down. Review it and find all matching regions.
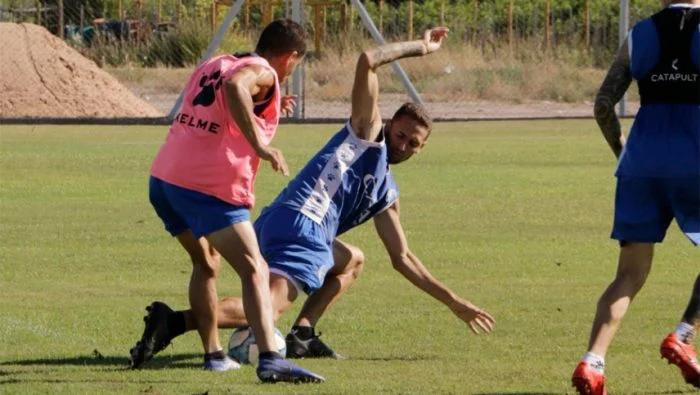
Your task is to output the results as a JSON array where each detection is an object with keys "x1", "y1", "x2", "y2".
[{"x1": 384, "y1": 103, "x2": 433, "y2": 164}]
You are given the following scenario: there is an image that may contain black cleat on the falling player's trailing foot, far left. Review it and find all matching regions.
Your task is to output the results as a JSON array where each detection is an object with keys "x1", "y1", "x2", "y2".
[{"x1": 129, "y1": 302, "x2": 173, "y2": 369}]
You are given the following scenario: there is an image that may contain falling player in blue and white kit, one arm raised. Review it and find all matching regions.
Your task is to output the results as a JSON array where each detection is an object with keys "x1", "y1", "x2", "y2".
[{"x1": 135, "y1": 28, "x2": 494, "y2": 366}]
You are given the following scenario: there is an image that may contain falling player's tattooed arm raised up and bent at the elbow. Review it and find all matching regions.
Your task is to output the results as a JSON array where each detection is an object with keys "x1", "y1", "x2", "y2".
[{"x1": 350, "y1": 27, "x2": 449, "y2": 140}]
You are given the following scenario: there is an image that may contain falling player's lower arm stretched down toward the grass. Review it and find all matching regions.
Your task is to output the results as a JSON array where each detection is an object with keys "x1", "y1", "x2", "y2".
[{"x1": 374, "y1": 201, "x2": 495, "y2": 333}]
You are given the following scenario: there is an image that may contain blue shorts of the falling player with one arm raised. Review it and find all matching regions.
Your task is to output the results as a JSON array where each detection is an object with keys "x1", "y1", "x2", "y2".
[{"x1": 255, "y1": 207, "x2": 333, "y2": 294}]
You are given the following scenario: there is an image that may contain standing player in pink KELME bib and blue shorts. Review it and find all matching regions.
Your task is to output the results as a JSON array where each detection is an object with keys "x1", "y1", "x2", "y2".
[{"x1": 130, "y1": 20, "x2": 323, "y2": 382}]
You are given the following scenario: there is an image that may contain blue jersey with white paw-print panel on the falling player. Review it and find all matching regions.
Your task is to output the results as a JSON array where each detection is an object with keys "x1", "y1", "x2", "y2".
[{"x1": 267, "y1": 122, "x2": 399, "y2": 240}]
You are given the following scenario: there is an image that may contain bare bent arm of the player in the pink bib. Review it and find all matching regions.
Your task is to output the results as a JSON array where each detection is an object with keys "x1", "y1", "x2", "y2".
[{"x1": 224, "y1": 65, "x2": 289, "y2": 176}]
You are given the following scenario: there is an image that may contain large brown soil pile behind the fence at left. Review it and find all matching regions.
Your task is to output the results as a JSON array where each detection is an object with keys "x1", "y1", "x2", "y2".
[{"x1": 0, "y1": 23, "x2": 162, "y2": 118}]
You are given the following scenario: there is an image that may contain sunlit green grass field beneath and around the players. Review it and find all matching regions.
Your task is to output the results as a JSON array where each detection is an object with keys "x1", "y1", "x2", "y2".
[{"x1": 0, "y1": 121, "x2": 700, "y2": 394}]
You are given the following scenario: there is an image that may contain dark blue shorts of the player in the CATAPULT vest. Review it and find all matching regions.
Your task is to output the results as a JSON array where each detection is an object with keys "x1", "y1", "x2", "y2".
[{"x1": 610, "y1": 176, "x2": 700, "y2": 245}]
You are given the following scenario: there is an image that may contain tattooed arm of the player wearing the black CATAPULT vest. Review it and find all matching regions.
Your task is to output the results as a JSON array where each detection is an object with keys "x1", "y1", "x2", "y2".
[{"x1": 594, "y1": 40, "x2": 632, "y2": 158}]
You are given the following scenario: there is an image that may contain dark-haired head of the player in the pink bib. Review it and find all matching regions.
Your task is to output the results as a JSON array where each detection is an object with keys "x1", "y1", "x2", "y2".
[{"x1": 255, "y1": 19, "x2": 306, "y2": 82}]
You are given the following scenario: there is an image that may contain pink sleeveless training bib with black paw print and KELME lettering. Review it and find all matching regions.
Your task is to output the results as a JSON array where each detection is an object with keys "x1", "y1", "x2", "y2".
[{"x1": 151, "y1": 55, "x2": 281, "y2": 207}]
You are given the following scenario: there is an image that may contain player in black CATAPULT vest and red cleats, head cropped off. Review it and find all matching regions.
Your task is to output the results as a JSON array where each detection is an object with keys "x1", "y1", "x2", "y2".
[{"x1": 572, "y1": 0, "x2": 700, "y2": 395}]
